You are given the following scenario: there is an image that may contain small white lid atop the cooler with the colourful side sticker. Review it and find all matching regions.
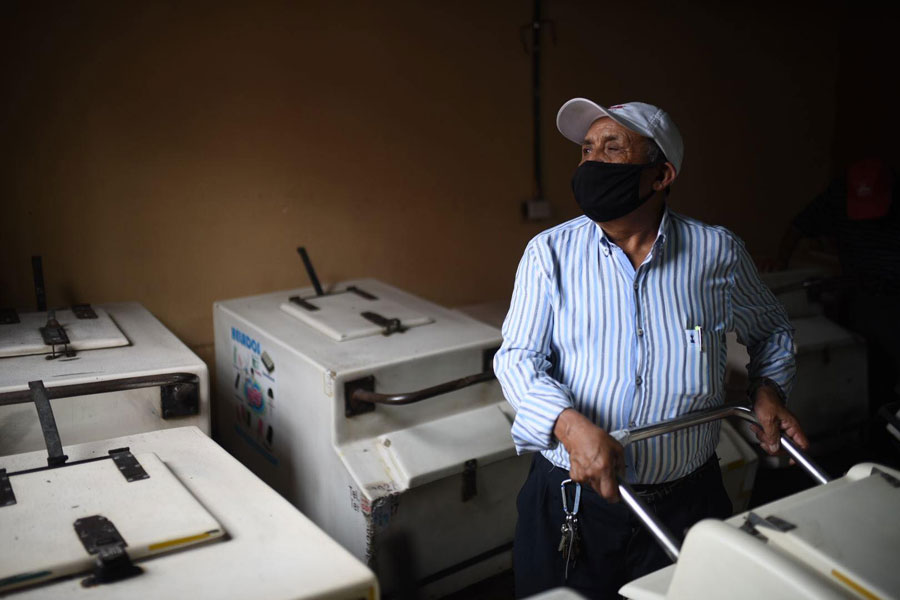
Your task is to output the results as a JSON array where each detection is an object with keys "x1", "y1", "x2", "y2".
[{"x1": 281, "y1": 291, "x2": 434, "y2": 342}]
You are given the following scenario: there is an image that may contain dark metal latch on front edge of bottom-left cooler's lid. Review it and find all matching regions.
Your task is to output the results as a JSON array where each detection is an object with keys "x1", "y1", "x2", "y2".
[{"x1": 74, "y1": 515, "x2": 143, "y2": 587}]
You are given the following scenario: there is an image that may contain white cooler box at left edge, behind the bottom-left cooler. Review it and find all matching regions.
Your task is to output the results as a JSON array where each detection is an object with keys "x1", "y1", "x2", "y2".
[{"x1": 0, "y1": 302, "x2": 210, "y2": 456}]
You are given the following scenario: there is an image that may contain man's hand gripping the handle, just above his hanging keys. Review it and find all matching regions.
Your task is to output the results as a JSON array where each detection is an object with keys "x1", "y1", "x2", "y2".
[{"x1": 553, "y1": 408, "x2": 625, "y2": 502}]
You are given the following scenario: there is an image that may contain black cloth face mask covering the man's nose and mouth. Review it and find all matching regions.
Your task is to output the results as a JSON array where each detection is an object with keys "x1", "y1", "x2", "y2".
[{"x1": 572, "y1": 160, "x2": 654, "y2": 223}]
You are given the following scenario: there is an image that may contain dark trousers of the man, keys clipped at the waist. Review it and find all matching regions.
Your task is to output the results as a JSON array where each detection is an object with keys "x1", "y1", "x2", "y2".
[{"x1": 513, "y1": 454, "x2": 732, "y2": 598}]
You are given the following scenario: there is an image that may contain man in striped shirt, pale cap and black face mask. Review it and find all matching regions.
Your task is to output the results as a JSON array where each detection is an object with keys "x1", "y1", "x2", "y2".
[{"x1": 494, "y1": 98, "x2": 806, "y2": 598}]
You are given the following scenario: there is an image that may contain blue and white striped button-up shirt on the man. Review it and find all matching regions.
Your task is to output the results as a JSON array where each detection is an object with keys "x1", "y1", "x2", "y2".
[{"x1": 494, "y1": 209, "x2": 795, "y2": 483}]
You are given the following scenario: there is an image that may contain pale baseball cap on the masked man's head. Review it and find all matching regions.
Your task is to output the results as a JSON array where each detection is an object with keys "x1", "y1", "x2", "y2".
[{"x1": 556, "y1": 98, "x2": 684, "y2": 173}]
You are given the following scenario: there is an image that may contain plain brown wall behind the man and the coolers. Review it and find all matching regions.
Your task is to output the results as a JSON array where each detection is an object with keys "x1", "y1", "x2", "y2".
[{"x1": 0, "y1": 0, "x2": 838, "y2": 360}]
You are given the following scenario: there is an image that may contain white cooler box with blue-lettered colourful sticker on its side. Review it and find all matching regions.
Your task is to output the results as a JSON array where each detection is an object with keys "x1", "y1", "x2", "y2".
[{"x1": 213, "y1": 279, "x2": 530, "y2": 596}]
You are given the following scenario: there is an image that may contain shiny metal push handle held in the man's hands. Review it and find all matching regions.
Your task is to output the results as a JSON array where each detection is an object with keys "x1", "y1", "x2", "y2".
[{"x1": 611, "y1": 406, "x2": 831, "y2": 561}]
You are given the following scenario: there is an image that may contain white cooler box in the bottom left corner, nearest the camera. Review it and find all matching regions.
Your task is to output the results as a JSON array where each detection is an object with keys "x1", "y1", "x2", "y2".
[{"x1": 0, "y1": 424, "x2": 378, "y2": 600}]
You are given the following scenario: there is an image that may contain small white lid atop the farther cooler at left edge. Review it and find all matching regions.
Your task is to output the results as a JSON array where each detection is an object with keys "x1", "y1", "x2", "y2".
[{"x1": 0, "y1": 308, "x2": 129, "y2": 358}]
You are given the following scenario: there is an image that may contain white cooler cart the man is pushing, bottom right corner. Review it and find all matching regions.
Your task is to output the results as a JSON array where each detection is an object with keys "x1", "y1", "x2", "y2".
[{"x1": 619, "y1": 463, "x2": 900, "y2": 600}]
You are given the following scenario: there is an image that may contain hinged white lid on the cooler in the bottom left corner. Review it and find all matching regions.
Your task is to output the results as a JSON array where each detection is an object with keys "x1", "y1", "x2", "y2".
[{"x1": 0, "y1": 453, "x2": 224, "y2": 593}]
